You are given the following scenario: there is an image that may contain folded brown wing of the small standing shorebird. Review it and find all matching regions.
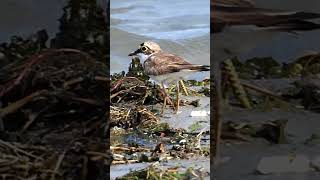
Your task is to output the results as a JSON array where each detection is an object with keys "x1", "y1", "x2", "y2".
[{"x1": 144, "y1": 52, "x2": 210, "y2": 75}]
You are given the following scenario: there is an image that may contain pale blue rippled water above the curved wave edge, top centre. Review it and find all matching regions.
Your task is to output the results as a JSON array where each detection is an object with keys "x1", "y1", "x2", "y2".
[{"x1": 111, "y1": 0, "x2": 210, "y2": 40}]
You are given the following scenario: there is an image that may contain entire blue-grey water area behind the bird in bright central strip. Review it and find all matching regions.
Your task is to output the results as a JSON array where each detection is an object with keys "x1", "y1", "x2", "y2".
[{"x1": 110, "y1": 0, "x2": 210, "y2": 76}]
